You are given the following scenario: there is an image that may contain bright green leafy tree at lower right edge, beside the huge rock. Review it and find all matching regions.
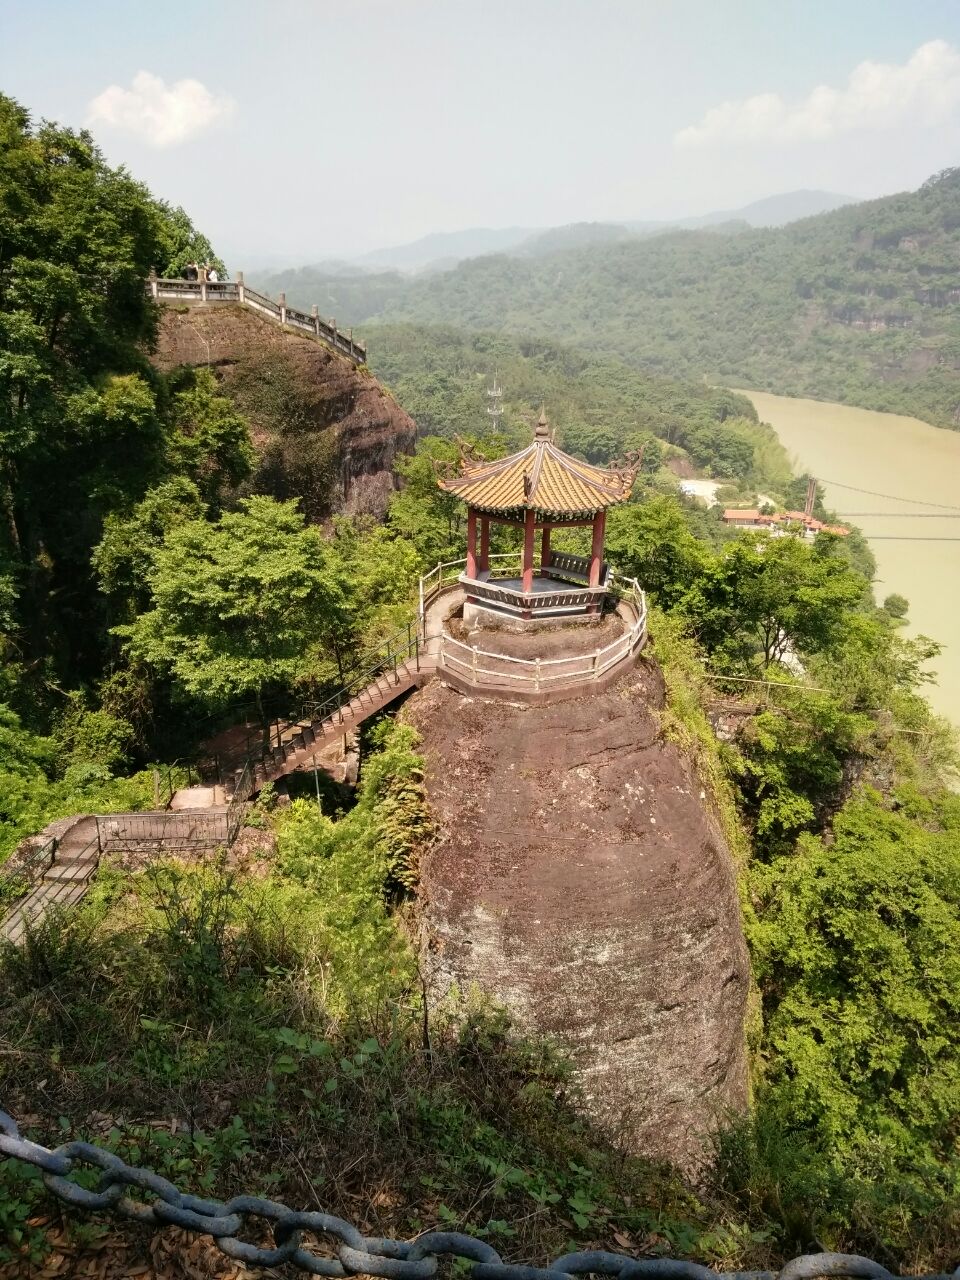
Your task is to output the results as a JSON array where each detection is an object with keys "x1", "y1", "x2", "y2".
[{"x1": 751, "y1": 791, "x2": 960, "y2": 1181}]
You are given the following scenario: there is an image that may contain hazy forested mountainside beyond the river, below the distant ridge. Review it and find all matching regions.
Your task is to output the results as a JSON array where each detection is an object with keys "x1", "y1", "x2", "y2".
[{"x1": 262, "y1": 169, "x2": 960, "y2": 428}]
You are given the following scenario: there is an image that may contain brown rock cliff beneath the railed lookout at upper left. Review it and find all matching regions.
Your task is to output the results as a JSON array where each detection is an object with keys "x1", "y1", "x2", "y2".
[{"x1": 154, "y1": 303, "x2": 416, "y2": 520}]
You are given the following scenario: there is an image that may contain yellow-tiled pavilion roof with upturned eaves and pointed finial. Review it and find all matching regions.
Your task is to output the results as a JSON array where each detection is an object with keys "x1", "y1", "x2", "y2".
[{"x1": 438, "y1": 413, "x2": 637, "y2": 518}]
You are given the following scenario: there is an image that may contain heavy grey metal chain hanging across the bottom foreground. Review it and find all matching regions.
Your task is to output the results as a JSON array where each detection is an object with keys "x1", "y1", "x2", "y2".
[{"x1": 0, "y1": 1111, "x2": 960, "y2": 1280}]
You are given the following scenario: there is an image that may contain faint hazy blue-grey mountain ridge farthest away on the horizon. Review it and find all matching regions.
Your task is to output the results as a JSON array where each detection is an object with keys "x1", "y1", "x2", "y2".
[{"x1": 330, "y1": 191, "x2": 854, "y2": 275}]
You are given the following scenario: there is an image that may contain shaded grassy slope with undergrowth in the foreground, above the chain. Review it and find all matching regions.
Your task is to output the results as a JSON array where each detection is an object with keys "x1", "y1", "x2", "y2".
[{"x1": 0, "y1": 867, "x2": 769, "y2": 1263}]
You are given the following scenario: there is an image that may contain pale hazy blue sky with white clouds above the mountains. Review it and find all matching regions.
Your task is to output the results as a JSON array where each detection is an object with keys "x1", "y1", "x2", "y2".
[{"x1": 0, "y1": 0, "x2": 960, "y2": 266}]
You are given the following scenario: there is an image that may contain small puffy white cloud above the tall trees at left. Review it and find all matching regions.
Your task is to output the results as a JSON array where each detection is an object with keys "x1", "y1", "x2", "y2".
[{"x1": 87, "y1": 72, "x2": 237, "y2": 147}]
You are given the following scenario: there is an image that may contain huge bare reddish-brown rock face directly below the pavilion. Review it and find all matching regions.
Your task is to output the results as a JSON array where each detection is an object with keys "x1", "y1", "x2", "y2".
[{"x1": 406, "y1": 660, "x2": 749, "y2": 1171}]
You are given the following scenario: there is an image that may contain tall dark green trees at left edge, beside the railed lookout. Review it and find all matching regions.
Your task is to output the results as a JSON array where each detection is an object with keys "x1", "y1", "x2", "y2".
[{"x1": 0, "y1": 95, "x2": 221, "y2": 708}]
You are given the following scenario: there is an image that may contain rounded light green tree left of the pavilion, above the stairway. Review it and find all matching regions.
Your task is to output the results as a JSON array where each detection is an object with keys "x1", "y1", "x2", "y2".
[{"x1": 116, "y1": 497, "x2": 346, "y2": 724}]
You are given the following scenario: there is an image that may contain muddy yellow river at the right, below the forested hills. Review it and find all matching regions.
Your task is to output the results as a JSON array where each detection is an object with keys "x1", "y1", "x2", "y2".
[{"x1": 744, "y1": 392, "x2": 960, "y2": 726}]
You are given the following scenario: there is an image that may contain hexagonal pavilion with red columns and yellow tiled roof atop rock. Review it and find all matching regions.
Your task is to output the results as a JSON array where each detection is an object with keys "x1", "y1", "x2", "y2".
[{"x1": 438, "y1": 412, "x2": 639, "y2": 622}]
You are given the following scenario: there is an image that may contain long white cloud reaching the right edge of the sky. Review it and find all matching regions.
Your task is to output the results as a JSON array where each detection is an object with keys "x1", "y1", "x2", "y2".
[{"x1": 673, "y1": 40, "x2": 960, "y2": 147}]
